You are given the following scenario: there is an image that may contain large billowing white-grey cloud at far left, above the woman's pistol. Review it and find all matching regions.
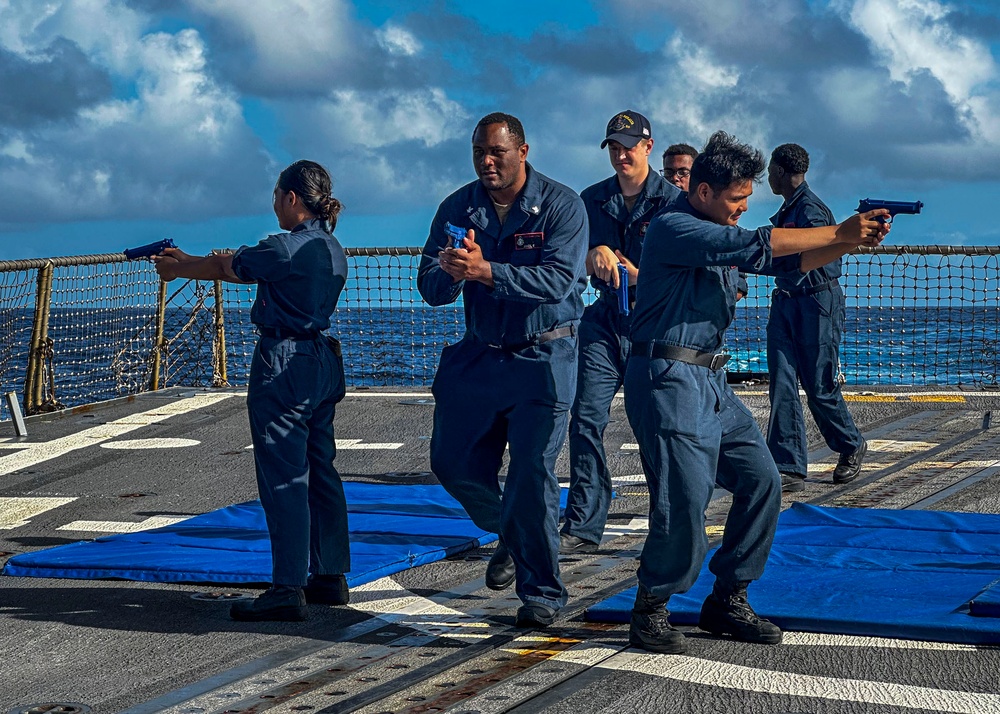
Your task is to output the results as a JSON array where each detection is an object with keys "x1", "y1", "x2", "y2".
[{"x1": 0, "y1": 5, "x2": 269, "y2": 222}]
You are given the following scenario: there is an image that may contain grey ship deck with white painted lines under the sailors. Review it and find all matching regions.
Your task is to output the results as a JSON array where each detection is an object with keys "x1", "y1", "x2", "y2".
[{"x1": 0, "y1": 386, "x2": 1000, "y2": 714}]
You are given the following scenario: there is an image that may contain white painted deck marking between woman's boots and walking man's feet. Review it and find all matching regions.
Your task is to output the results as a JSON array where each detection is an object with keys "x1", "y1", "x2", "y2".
[{"x1": 350, "y1": 578, "x2": 490, "y2": 640}]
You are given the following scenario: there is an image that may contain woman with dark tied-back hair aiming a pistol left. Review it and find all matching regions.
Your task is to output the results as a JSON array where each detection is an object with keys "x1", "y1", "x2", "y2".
[{"x1": 153, "y1": 161, "x2": 351, "y2": 621}]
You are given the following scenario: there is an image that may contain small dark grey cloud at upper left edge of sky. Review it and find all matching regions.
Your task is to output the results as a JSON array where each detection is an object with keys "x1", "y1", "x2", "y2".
[{"x1": 0, "y1": 38, "x2": 112, "y2": 128}]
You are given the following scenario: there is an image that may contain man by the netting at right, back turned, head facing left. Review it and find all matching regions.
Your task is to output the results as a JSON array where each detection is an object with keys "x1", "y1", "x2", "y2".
[{"x1": 767, "y1": 144, "x2": 868, "y2": 492}]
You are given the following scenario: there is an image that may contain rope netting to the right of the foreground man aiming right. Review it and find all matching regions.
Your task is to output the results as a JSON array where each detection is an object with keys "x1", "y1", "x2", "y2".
[{"x1": 727, "y1": 246, "x2": 1000, "y2": 388}]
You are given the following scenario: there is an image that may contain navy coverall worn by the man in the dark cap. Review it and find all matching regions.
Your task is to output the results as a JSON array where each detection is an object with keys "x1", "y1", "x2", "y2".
[{"x1": 562, "y1": 171, "x2": 680, "y2": 543}]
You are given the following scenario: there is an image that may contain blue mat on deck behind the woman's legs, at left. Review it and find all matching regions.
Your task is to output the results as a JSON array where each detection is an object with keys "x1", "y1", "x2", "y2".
[{"x1": 3, "y1": 482, "x2": 566, "y2": 586}]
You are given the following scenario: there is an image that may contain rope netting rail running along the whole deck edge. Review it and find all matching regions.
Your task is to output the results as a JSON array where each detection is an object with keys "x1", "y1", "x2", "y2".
[{"x1": 0, "y1": 246, "x2": 1000, "y2": 418}]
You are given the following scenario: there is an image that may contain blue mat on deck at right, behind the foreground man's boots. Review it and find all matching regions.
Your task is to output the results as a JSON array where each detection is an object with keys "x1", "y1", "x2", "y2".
[{"x1": 586, "y1": 503, "x2": 1000, "y2": 644}]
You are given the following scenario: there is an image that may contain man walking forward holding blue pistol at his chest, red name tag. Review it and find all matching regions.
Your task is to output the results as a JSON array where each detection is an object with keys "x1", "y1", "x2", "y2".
[{"x1": 417, "y1": 113, "x2": 587, "y2": 627}]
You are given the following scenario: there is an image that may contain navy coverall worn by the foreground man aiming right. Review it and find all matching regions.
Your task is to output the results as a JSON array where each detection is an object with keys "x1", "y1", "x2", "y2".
[{"x1": 625, "y1": 194, "x2": 799, "y2": 599}]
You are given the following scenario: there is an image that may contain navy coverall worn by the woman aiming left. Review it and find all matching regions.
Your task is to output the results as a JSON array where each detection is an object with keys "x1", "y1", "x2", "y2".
[{"x1": 233, "y1": 220, "x2": 351, "y2": 587}]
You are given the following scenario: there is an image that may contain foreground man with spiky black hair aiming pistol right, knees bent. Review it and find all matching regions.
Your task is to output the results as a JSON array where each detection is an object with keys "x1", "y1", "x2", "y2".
[{"x1": 625, "y1": 132, "x2": 887, "y2": 653}]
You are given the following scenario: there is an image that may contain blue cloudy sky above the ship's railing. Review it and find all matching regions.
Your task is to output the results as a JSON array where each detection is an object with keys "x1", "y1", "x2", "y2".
[{"x1": 0, "y1": 0, "x2": 1000, "y2": 260}]
